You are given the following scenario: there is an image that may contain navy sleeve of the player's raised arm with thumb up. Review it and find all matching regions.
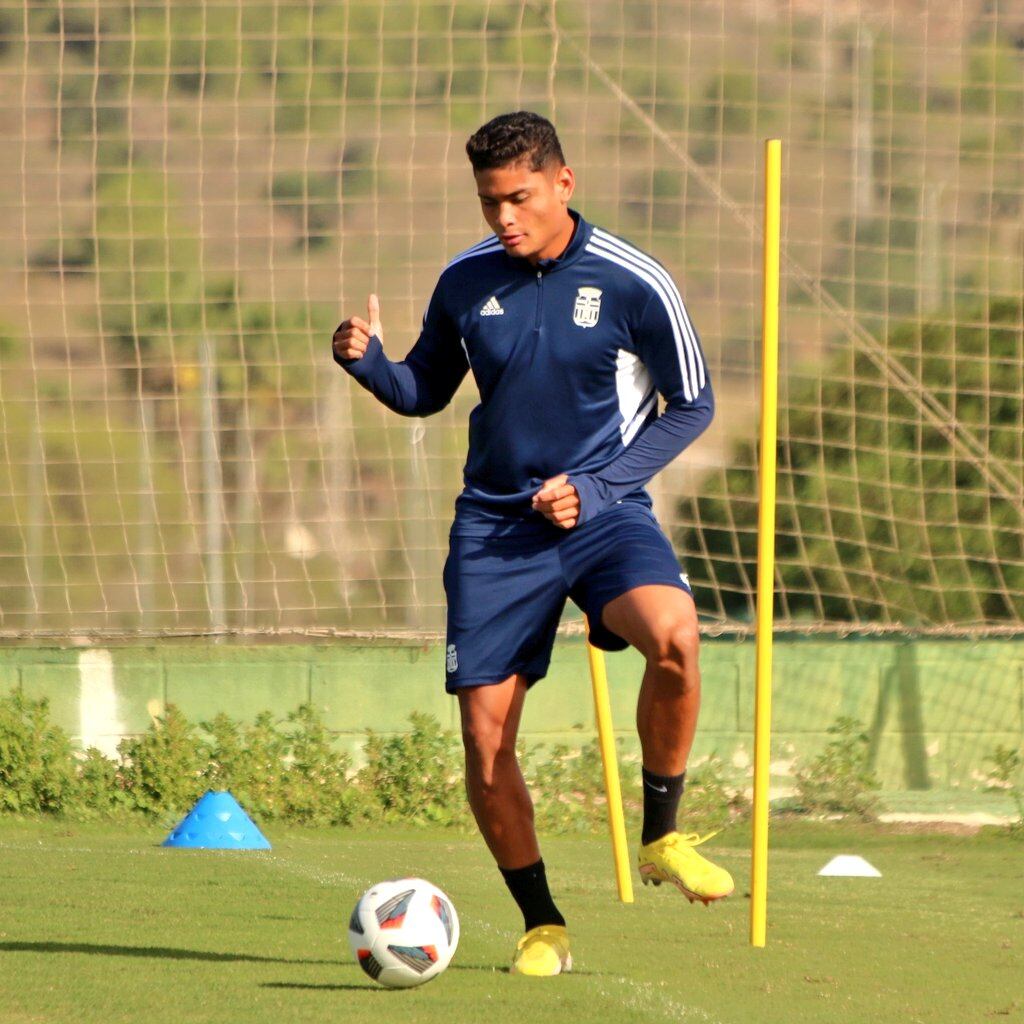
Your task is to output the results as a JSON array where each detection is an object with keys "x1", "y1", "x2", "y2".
[{"x1": 338, "y1": 283, "x2": 469, "y2": 416}]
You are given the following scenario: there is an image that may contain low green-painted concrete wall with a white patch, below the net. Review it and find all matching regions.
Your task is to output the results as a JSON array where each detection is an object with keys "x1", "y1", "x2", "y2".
[{"x1": 0, "y1": 639, "x2": 1024, "y2": 791}]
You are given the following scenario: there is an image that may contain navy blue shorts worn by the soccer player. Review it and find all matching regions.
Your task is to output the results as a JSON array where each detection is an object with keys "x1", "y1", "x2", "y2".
[{"x1": 444, "y1": 502, "x2": 690, "y2": 693}]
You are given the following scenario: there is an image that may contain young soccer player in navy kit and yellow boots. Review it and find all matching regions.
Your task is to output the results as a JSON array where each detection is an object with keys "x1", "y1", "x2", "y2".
[{"x1": 333, "y1": 112, "x2": 732, "y2": 976}]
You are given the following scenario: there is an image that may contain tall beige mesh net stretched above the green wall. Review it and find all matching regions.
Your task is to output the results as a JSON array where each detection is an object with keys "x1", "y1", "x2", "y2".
[{"x1": 0, "y1": 0, "x2": 1024, "y2": 636}]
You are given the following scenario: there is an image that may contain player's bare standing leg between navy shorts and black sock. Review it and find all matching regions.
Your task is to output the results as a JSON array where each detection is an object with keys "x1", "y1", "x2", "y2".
[{"x1": 459, "y1": 676, "x2": 541, "y2": 870}]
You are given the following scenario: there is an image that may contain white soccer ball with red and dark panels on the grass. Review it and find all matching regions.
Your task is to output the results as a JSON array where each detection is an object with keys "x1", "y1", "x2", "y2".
[{"x1": 348, "y1": 879, "x2": 459, "y2": 988}]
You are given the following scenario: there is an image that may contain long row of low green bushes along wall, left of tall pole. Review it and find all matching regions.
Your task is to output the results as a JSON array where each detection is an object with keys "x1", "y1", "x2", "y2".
[{"x1": 0, "y1": 693, "x2": 746, "y2": 833}]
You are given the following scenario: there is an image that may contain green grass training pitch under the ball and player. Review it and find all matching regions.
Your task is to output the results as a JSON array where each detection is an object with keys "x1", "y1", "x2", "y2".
[{"x1": 0, "y1": 821, "x2": 1024, "y2": 1024}]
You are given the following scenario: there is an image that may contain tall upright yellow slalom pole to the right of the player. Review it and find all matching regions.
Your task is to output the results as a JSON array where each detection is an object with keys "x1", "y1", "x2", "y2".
[{"x1": 751, "y1": 138, "x2": 782, "y2": 947}]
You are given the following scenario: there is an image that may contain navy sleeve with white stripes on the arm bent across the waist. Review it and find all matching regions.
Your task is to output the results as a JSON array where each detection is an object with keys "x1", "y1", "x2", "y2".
[{"x1": 568, "y1": 288, "x2": 715, "y2": 524}]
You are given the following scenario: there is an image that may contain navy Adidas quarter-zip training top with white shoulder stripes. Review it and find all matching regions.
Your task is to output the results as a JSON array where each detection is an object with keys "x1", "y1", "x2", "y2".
[{"x1": 341, "y1": 210, "x2": 715, "y2": 536}]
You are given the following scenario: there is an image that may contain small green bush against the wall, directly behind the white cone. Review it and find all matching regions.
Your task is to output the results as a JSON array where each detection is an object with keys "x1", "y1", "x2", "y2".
[{"x1": 793, "y1": 717, "x2": 881, "y2": 821}]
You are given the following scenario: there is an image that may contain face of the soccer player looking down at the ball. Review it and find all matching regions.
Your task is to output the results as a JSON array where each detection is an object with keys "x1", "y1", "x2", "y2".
[{"x1": 474, "y1": 162, "x2": 575, "y2": 263}]
